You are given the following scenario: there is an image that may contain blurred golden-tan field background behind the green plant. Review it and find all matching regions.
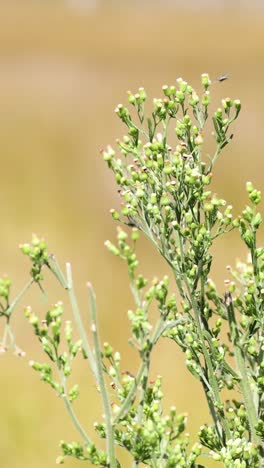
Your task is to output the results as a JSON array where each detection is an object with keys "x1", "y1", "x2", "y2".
[{"x1": 0, "y1": 0, "x2": 264, "y2": 468}]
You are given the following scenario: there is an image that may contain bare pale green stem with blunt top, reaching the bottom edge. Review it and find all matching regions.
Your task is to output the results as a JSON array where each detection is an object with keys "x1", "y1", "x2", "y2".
[{"x1": 87, "y1": 283, "x2": 117, "y2": 468}]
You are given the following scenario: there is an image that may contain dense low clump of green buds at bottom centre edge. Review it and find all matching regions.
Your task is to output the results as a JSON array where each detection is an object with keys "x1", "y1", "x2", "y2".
[{"x1": 95, "y1": 373, "x2": 202, "y2": 467}]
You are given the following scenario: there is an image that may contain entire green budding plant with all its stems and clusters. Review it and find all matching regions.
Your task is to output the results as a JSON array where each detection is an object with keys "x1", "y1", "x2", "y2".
[{"x1": 0, "y1": 74, "x2": 264, "y2": 468}]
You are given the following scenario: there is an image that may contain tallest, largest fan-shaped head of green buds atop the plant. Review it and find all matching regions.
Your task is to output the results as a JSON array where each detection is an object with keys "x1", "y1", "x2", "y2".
[{"x1": 103, "y1": 74, "x2": 241, "y2": 338}]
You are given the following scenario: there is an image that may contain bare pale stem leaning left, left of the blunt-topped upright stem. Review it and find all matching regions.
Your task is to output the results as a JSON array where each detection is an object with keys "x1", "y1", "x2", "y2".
[{"x1": 66, "y1": 263, "x2": 98, "y2": 381}]
